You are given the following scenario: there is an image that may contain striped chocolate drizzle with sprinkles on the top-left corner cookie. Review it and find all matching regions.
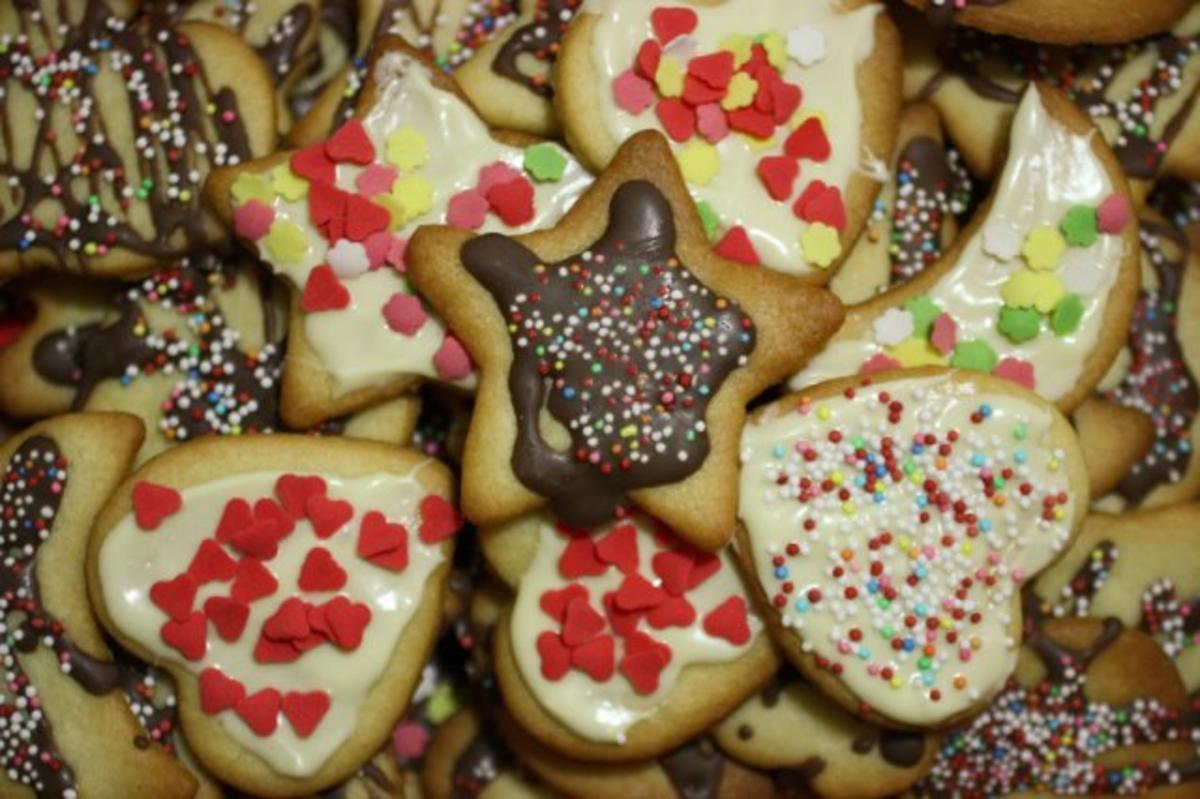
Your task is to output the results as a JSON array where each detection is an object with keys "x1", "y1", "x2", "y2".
[{"x1": 0, "y1": 0, "x2": 250, "y2": 269}]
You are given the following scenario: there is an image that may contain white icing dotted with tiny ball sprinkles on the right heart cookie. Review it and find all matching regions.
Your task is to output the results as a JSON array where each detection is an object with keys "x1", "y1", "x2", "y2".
[{"x1": 739, "y1": 377, "x2": 1081, "y2": 726}]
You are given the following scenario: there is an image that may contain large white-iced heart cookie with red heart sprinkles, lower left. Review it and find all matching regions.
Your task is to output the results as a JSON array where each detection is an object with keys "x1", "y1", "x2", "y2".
[{"x1": 88, "y1": 435, "x2": 458, "y2": 797}]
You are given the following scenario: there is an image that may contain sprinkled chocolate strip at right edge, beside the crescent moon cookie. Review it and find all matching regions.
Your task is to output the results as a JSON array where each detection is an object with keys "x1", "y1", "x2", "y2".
[{"x1": 1104, "y1": 220, "x2": 1200, "y2": 505}]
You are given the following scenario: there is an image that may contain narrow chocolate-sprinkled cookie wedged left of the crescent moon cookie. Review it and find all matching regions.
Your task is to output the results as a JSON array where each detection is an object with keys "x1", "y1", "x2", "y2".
[{"x1": 829, "y1": 103, "x2": 974, "y2": 304}]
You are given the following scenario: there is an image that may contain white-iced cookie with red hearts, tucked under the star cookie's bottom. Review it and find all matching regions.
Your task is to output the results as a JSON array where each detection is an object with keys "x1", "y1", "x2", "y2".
[{"x1": 481, "y1": 513, "x2": 779, "y2": 763}]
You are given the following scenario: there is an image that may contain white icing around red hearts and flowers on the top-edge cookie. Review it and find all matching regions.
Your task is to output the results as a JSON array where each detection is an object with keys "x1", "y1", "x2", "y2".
[{"x1": 582, "y1": 0, "x2": 882, "y2": 274}]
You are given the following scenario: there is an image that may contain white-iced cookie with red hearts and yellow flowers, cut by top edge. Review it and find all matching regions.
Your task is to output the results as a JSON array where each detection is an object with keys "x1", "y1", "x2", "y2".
[{"x1": 556, "y1": 0, "x2": 900, "y2": 282}]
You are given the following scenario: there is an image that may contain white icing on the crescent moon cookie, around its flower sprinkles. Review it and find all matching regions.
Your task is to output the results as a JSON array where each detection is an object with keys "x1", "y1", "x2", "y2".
[{"x1": 791, "y1": 89, "x2": 1126, "y2": 401}]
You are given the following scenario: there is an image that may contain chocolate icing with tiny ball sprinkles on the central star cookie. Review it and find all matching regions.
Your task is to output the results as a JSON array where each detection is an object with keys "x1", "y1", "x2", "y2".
[{"x1": 462, "y1": 181, "x2": 755, "y2": 527}]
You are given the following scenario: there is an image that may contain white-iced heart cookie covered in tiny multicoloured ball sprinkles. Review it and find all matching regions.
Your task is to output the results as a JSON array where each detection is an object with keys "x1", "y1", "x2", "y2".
[{"x1": 737, "y1": 370, "x2": 1088, "y2": 731}]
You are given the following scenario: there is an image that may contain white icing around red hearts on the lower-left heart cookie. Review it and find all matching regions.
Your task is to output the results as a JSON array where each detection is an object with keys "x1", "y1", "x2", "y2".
[{"x1": 98, "y1": 470, "x2": 444, "y2": 777}]
